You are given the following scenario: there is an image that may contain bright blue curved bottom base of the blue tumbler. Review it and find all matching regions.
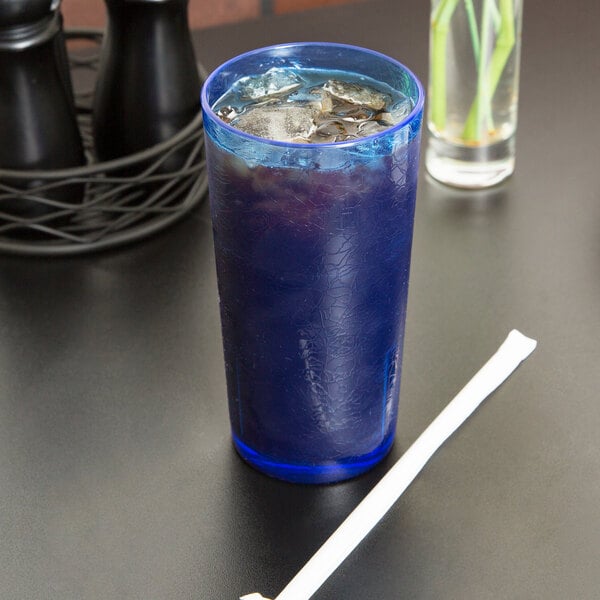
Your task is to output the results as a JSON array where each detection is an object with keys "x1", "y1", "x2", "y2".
[{"x1": 232, "y1": 434, "x2": 394, "y2": 484}]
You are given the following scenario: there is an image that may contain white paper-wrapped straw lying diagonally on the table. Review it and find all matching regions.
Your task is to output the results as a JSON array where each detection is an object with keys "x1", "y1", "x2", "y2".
[{"x1": 240, "y1": 329, "x2": 537, "y2": 600}]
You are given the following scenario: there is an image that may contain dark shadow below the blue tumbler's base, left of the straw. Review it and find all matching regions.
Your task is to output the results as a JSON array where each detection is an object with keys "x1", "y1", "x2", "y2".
[{"x1": 215, "y1": 438, "x2": 404, "y2": 600}]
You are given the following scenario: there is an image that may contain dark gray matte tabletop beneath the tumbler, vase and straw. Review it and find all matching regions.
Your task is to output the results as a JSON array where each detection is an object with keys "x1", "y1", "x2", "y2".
[{"x1": 0, "y1": 0, "x2": 600, "y2": 600}]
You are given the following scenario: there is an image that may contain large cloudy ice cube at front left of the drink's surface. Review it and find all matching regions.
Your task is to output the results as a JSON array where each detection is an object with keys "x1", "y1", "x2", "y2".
[{"x1": 231, "y1": 104, "x2": 318, "y2": 142}]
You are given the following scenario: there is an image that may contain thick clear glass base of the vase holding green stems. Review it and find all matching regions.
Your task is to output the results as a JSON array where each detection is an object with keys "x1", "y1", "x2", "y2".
[{"x1": 425, "y1": 137, "x2": 515, "y2": 189}]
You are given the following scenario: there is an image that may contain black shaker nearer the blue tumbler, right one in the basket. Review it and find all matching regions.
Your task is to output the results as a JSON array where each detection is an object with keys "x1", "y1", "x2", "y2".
[{"x1": 93, "y1": 0, "x2": 200, "y2": 170}]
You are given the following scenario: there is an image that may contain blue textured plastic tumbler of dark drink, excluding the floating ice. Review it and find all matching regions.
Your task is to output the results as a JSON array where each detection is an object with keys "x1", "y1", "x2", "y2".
[{"x1": 202, "y1": 44, "x2": 423, "y2": 483}]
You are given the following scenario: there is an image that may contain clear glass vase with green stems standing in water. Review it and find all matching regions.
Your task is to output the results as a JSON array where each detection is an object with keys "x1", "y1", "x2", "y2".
[{"x1": 426, "y1": 0, "x2": 523, "y2": 188}]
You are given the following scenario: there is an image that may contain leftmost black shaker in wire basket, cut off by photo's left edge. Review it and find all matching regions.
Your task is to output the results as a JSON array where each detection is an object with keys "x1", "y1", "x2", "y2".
[{"x1": 0, "y1": 0, "x2": 85, "y2": 230}]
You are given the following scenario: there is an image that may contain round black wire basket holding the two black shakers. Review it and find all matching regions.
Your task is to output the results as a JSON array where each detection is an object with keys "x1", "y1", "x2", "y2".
[{"x1": 0, "y1": 29, "x2": 208, "y2": 255}]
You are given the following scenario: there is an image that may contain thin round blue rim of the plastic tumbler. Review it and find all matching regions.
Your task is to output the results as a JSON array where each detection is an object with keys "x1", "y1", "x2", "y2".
[{"x1": 200, "y1": 42, "x2": 425, "y2": 149}]
